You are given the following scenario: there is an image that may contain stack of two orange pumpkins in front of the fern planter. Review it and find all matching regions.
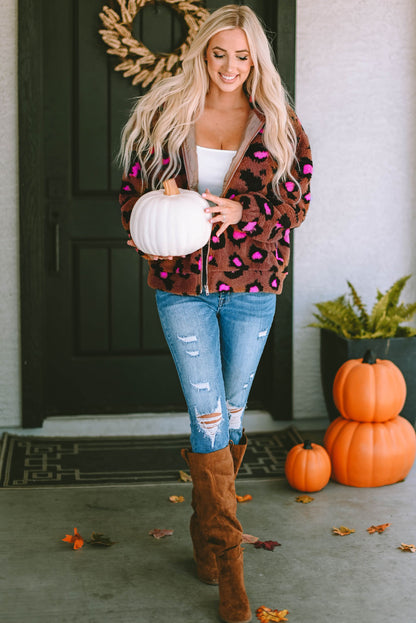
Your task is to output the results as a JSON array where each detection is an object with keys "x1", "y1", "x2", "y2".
[{"x1": 324, "y1": 351, "x2": 416, "y2": 487}]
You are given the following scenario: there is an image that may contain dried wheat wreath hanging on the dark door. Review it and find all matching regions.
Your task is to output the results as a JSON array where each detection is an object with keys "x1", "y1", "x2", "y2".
[{"x1": 99, "y1": 0, "x2": 209, "y2": 87}]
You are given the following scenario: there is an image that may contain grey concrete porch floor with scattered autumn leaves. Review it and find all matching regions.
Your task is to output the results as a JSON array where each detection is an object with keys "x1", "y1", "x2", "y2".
[{"x1": 0, "y1": 430, "x2": 416, "y2": 623}]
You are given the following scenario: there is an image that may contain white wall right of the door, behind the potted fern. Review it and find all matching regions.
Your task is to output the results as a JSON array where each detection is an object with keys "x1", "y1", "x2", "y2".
[{"x1": 294, "y1": 0, "x2": 416, "y2": 418}]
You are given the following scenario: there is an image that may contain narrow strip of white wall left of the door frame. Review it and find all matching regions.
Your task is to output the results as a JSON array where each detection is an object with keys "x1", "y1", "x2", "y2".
[{"x1": 0, "y1": 0, "x2": 20, "y2": 426}]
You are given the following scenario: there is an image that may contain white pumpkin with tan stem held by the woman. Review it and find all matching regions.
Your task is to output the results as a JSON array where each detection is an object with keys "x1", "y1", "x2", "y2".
[{"x1": 130, "y1": 180, "x2": 211, "y2": 257}]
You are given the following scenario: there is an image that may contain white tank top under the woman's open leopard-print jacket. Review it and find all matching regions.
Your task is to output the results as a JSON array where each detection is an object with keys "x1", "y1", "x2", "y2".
[{"x1": 196, "y1": 145, "x2": 237, "y2": 196}]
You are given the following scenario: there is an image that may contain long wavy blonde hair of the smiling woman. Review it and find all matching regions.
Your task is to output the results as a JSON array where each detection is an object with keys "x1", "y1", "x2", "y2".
[{"x1": 119, "y1": 4, "x2": 296, "y2": 196}]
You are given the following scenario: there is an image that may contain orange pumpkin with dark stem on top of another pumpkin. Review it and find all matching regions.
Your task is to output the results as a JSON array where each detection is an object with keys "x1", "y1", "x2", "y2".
[{"x1": 333, "y1": 351, "x2": 406, "y2": 422}]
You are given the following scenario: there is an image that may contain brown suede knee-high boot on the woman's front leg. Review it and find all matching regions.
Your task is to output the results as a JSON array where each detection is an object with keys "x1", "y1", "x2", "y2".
[{"x1": 182, "y1": 446, "x2": 252, "y2": 623}]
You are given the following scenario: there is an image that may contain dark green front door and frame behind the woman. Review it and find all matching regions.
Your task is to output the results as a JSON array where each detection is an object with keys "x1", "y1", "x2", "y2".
[{"x1": 19, "y1": 0, "x2": 291, "y2": 426}]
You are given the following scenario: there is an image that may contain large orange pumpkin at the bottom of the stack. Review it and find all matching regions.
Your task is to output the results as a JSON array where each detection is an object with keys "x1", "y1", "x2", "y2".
[{"x1": 324, "y1": 416, "x2": 416, "y2": 487}]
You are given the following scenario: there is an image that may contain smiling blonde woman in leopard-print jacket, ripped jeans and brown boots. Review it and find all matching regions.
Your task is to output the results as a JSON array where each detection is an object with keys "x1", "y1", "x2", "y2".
[{"x1": 120, "y1": 5, "x2": 312, "y2": 623}]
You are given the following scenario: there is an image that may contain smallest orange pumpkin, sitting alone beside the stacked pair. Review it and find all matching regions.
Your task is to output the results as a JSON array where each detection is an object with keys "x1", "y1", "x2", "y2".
[{"x1": 285, "y1": 441, "x2": 331, "y2": 493}]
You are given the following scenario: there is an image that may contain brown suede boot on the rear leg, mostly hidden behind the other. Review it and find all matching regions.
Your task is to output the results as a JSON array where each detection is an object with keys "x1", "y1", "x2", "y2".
[{"x1": 182, "y1": 431, "x2": 247, "y2": 584}]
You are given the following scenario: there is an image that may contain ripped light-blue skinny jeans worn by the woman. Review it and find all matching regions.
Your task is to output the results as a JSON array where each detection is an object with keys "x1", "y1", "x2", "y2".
[{"x1": 156, "y1": 290, "x2": 276, "y2": 453}]
